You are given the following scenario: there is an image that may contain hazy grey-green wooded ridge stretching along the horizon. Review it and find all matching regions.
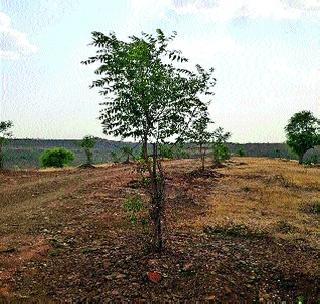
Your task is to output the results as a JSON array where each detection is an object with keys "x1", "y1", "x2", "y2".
[{"x1": 4, "y1": 139, "x2": 320, "y2": 169}]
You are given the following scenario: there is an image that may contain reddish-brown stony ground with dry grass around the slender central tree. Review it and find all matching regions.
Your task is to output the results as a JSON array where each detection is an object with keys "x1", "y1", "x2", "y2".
[{"x1": 0, "y1": 158, "x2": 320, "y2": 303}]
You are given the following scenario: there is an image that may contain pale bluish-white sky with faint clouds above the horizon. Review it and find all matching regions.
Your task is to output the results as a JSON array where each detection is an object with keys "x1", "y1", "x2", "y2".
[{"x1": 0, "y1": 0, "x2": 320, "y2": 142}]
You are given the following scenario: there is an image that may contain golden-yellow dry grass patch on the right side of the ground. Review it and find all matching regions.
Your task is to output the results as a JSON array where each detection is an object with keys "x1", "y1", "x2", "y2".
[{"x1": 194, "y1": 158, "x2": 320, "y2": 247}]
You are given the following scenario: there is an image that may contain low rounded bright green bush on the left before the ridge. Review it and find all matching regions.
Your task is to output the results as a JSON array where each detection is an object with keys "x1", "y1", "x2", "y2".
[{"x1": 40, "y1": 147, "x2": 74, "y2": 168}]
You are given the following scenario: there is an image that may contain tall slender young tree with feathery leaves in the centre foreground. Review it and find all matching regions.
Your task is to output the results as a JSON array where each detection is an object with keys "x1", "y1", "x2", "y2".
[{"x1": 83, "y1": 30, "x2": 215, "y2": 251}]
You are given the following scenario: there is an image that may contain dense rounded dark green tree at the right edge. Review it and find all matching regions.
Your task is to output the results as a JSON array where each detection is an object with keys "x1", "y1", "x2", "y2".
[{"x1": 285, "y1": 111, "x2": 320, "y2": 164}]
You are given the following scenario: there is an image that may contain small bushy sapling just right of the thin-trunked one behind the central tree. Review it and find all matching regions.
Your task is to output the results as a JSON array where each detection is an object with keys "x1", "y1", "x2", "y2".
[{"x1": 212, "y1": 127, "x2": 231, "y2": 165}]
